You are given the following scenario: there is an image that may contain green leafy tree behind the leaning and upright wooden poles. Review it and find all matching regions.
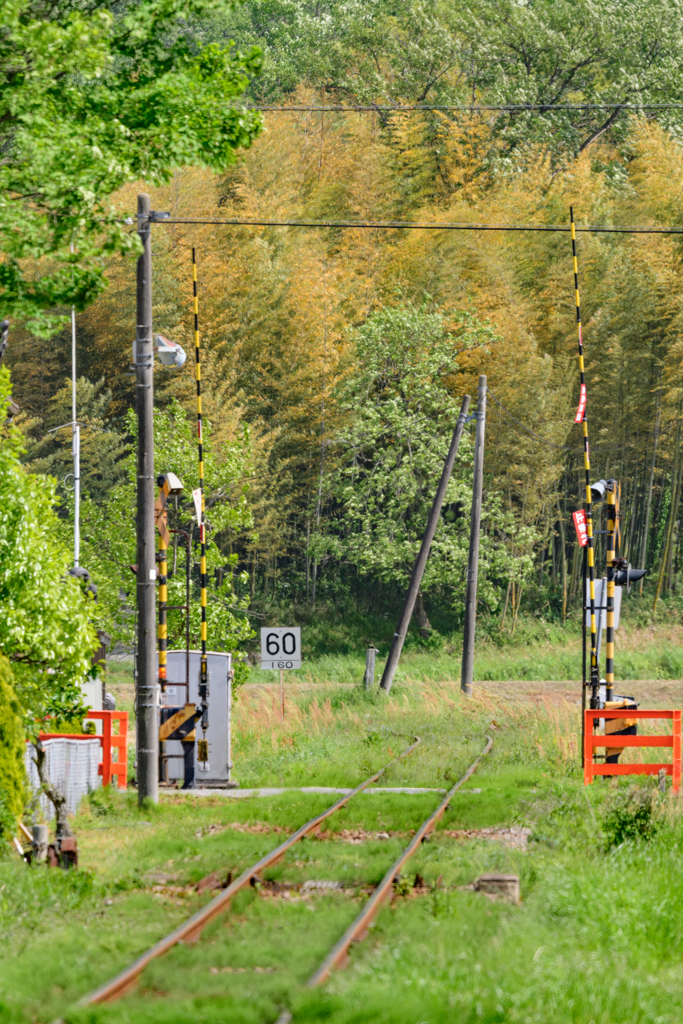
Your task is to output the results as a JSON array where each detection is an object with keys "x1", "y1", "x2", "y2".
[{"x1": 327, "y1": 305, "x2": 531, "y2": 606}]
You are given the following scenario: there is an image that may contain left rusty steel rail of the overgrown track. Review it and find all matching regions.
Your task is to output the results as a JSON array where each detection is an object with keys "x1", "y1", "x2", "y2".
[{"x1": 77, "y1": 736, "x2": 421, "y2": 1007}]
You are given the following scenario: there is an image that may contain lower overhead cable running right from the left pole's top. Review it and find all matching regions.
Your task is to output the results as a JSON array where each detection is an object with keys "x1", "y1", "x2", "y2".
[{"x1": 151, "y1": 214, "x2": 683, "y2": 234}]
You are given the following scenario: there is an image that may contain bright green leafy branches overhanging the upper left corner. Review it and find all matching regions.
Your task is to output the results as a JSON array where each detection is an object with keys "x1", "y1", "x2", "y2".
[{"x1": 0, "y1": 0, "x2": 260, "y2": 335}]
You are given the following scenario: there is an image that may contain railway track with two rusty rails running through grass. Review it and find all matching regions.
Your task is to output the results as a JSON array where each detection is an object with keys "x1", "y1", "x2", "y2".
[{"x1": 77, "y1": 736, "x2": 494, "y2": 1019}]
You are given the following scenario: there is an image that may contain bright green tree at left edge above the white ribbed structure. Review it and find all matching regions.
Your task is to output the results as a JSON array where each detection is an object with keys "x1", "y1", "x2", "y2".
[{"x1": 0, "y1": 368, "x2": 97, "y2": 729}]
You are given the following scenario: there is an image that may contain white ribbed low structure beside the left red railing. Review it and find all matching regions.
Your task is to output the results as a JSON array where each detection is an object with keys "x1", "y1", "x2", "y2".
[{"x1": 25, "y1": 736, "x2": 102, "y2": 821}]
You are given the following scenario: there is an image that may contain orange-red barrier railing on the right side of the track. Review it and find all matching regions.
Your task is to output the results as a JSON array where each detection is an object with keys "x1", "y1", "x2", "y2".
[{"x1": 584, "y1": 708, "x2": 682, "y2": 793}]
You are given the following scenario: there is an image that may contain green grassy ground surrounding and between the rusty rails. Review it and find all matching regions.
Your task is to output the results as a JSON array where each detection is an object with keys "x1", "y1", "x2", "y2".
[{"x1": 0, "y1": 683, "x2": 683, "y2": 1024}]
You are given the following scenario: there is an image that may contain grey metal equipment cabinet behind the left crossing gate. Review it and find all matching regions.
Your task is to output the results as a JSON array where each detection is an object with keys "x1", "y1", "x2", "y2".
[{"x1": 160, "y1": 650, "x2": 237, "y2": 788}]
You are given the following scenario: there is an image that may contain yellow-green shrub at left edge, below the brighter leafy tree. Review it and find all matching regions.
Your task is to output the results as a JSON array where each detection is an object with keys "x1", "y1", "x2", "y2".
[{"x1": 0, "y1": 654, "x2": 26, "y2": 849}]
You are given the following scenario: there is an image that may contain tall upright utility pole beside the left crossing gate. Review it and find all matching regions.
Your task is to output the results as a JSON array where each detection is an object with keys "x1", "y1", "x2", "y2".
[{"x1": 134, "y1": 194, "x2": 159, "y2": 804}]
